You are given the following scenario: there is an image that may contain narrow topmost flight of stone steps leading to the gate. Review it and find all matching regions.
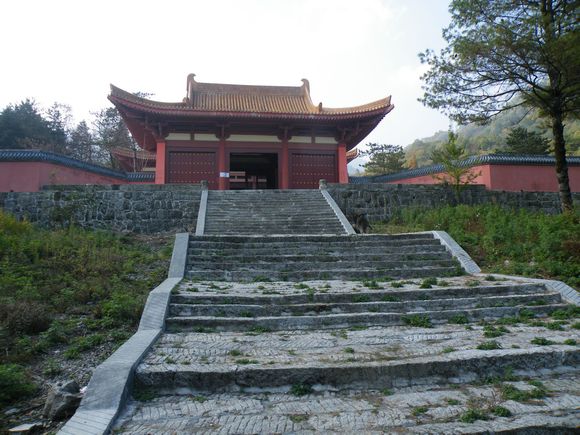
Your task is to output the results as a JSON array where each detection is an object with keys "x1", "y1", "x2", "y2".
[{"x1": 205, "y1": 190, "x2": 345, "y2": 235}]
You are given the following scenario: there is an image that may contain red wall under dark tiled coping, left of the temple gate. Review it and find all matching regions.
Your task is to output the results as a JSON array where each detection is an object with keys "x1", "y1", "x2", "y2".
[{"x1": 0, "y1": 162, "x2": 145, "y2": 192}]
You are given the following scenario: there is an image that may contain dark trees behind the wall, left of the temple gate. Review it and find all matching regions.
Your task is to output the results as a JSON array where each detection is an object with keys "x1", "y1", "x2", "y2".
[{"x1": 0, "y1": 99, "x2": 137, "y2": 167}]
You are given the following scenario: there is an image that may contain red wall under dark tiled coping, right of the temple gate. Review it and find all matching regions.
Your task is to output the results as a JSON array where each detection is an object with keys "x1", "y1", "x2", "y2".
[{"x1": 388, "y1": 165, "x2": 580, "y2": 192}]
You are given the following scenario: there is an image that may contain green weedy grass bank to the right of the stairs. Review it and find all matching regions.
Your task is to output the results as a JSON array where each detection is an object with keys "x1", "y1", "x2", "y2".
[{"x1": 373, "y1": 204, "x2": 580, "y2": 289}]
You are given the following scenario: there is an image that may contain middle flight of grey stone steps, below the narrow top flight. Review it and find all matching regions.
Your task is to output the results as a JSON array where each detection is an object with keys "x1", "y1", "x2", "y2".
[{"x1": 186, "y1": 233, "x2": 463, "y2": 281}]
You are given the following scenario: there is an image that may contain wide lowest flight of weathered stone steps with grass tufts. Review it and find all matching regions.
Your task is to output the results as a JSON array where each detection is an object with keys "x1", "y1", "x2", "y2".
[{"x1": 115, "y1": 276, "x2": 580, "y2": 434}]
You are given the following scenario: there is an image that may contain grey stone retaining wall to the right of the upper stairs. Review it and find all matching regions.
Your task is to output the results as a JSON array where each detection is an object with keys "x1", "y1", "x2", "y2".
[{"x1": 327, "y1": 183, "x2": 580, "y2": 221}]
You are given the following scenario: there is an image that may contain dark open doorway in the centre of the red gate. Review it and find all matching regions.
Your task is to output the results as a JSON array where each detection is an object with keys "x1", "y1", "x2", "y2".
[{"x1": 230, "y1": 153, "x2": 278, "y2": 190}]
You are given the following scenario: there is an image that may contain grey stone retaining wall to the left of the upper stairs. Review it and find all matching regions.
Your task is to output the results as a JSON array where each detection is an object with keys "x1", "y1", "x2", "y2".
[{"x1": 0, "y1": 184, "x2": 201, "y2": 233}]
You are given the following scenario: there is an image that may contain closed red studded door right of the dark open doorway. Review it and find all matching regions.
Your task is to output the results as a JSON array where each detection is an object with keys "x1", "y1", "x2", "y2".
[{"x1": 290, "y1": 153, "x2": 338, "y2": 189}]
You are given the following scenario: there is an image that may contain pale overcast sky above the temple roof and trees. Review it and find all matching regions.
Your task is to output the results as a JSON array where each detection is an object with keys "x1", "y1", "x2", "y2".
[{"x1": 0, "y1": 0, "x2": 449, "y2": 160}]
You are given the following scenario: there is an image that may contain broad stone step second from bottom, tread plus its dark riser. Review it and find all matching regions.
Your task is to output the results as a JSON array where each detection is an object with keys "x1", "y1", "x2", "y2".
[{"x1": 136, "y1": 325, "x2": 580, "y2": 392}]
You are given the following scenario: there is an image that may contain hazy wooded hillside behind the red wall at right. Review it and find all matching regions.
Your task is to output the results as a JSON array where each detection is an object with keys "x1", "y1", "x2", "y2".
[{"x1": 405, "y1": 107, "x2": 580, "y2": 166}]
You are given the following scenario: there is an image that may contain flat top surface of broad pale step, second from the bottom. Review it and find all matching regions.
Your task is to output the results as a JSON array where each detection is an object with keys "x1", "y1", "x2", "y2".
[{"x1": 137, "y1": 325, "x2": 580, "y2": 377}]
